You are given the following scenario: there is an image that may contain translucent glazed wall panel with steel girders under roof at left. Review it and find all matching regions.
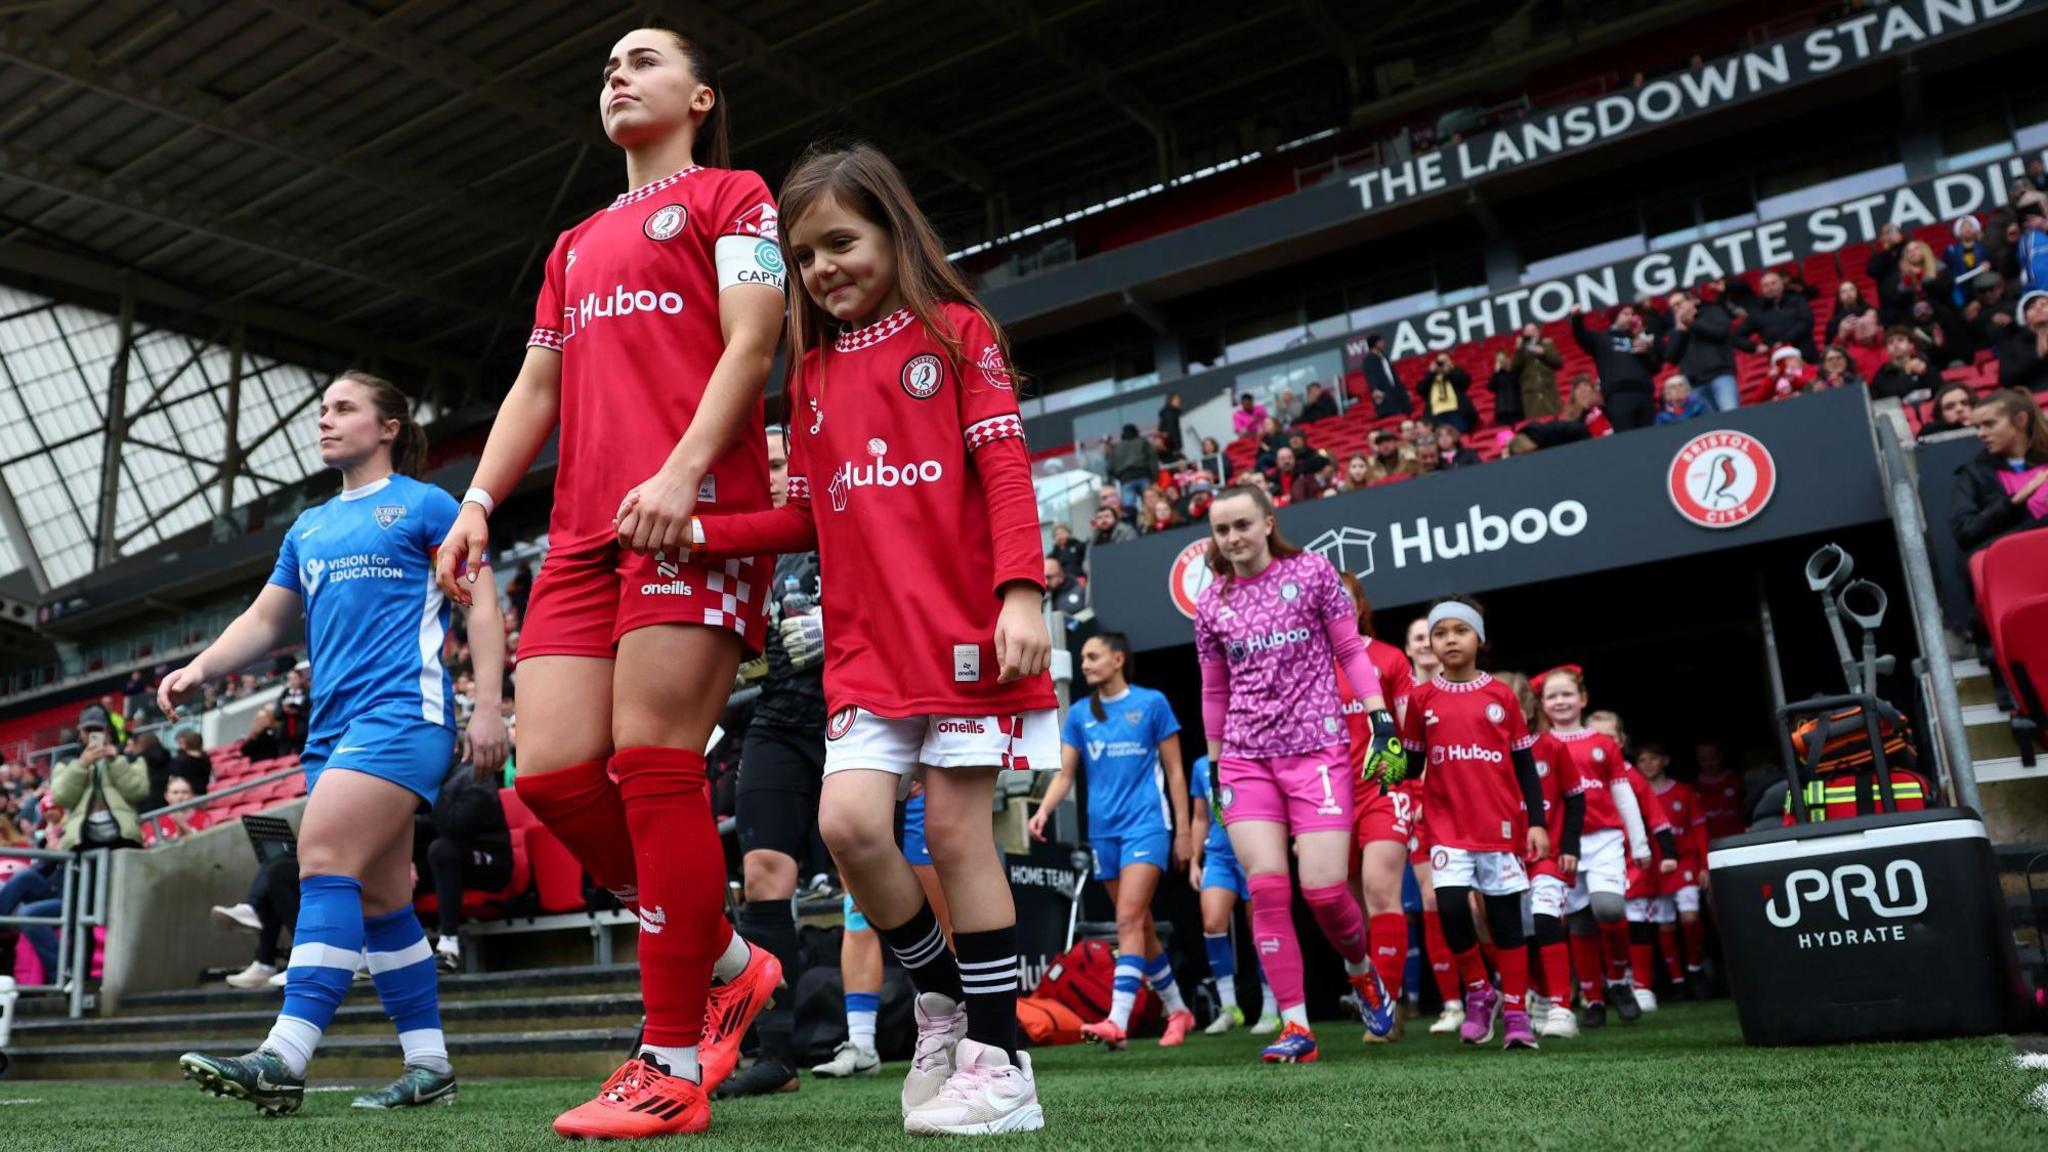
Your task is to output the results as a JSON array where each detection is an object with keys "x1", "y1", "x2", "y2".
[{"x1": 0, "y1": 287, "x2": 326, "y2": 592}]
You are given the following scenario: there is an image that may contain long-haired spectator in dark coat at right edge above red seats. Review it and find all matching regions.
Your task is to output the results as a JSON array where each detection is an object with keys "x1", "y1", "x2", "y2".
[{"x1": 1950, "y1": 387, "x2": 2048, "y2": 556}]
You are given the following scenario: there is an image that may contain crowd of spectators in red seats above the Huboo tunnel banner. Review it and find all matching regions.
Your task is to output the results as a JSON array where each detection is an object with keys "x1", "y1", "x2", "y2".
[{"x1": 1053, "y1": 186, "x2": 2048, "y2": 573}]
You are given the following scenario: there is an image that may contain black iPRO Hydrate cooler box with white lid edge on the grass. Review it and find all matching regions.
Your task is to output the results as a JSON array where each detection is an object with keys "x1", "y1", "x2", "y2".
[{"x1": 1706, "y1": 808, "x2": 2025, "y2": 1045}]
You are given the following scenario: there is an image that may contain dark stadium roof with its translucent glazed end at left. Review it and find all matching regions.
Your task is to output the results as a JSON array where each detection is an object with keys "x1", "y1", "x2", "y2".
[{"x1": 0, "y1": 0, "x2": 1726, "y2": 592}]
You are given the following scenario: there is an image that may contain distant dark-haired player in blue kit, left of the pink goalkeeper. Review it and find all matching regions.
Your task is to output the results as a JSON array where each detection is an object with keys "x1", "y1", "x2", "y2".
[{"x1": 1030, "y1": 631, "x2": 1194, "y2": 1052}]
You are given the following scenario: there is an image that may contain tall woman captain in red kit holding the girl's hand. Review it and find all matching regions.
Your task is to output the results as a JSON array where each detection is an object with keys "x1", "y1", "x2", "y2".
[{"x1": 436, "y1": 29, "x2": 782, "y2": 1138}]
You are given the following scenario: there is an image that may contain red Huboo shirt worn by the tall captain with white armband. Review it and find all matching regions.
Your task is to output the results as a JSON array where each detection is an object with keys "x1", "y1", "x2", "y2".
[{"x1": 526, "y1": 168, "x2": 782, "y2": 549}]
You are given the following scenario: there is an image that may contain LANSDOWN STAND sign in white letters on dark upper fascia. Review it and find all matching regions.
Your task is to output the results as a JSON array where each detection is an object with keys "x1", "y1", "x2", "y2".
[{"x1": 1350, "y1": 0, "x2": 2048, "y2": 211}]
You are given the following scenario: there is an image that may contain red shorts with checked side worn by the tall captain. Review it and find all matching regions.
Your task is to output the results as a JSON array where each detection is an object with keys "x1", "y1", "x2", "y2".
[{"x1": 518, "y1": 535, "x2": 774, "y2": 660}]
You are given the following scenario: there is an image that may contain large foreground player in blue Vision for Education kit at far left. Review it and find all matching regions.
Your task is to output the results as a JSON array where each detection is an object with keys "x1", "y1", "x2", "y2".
[{"x1": 158, "y1": 371, "x2": 506, "y2": 1115}]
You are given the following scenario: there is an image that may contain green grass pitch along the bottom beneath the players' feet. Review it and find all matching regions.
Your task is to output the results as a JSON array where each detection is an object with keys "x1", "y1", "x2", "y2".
[{"x1": 0, "y1": 1002, "x2": 2048, "y2": 1152}]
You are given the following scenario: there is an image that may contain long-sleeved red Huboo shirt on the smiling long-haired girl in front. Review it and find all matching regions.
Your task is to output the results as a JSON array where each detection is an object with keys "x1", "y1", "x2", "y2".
[{"x1": 702, "y1": 303, "x2": 1055, "y2": 717}]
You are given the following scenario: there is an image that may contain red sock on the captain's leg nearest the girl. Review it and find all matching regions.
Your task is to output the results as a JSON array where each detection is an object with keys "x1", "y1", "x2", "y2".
[{"x1": 612, "y1": 748, "x2": 731, "y2": 1047}]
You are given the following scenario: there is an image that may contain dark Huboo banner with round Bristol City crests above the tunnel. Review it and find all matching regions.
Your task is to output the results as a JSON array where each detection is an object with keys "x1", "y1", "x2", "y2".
[{"x1": 1090, "y1": 389, "x2": 1886, "y2": 650}]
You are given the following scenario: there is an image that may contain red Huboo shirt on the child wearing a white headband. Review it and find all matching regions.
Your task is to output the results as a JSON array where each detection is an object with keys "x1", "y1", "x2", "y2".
[{"x1": 1401, "y1": 672, "x2": 1536, "y2": 853}]
